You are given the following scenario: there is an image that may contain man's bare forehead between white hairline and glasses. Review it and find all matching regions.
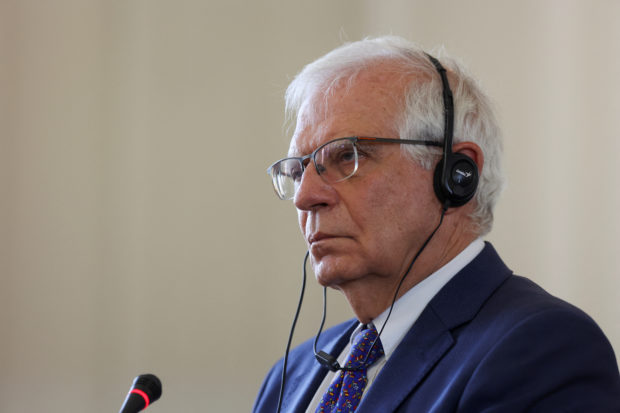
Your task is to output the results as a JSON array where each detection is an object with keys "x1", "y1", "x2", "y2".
[{"x1": 289, "y1": 64, "x2": 411, "y2": 156}]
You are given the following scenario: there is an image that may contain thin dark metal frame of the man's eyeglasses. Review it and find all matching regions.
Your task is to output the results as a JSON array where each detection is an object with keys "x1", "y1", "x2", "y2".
[{"x1": 267, "y1": 136, "x2": 444, "y2": 201}]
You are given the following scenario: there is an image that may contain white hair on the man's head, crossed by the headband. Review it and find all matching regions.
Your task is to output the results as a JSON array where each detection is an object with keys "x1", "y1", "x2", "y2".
[{"x1": 286, "y1": 36, "x2": 504, "y2": 235}]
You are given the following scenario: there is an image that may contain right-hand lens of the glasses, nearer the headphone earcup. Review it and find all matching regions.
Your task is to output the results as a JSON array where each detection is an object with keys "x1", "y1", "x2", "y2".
[{"x1": 315, "y1": 139, "x2": 357, "y2": 183}]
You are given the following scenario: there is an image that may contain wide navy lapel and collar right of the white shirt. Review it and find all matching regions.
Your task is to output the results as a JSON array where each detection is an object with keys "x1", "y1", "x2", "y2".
[{"x1": 357, "y1": 243, "x2": 511, "y2": 413}]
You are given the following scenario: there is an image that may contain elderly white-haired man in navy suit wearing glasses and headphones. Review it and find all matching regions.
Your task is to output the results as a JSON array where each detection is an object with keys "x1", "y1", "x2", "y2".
[{"x1": 254, "y1": 37, "x2": 620, "y2": 413}]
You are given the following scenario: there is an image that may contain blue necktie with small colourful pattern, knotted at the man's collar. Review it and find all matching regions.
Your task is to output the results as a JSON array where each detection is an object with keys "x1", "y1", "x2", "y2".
[{"x1": 315, "y1": 326, "x2": 383, "y2": 413}]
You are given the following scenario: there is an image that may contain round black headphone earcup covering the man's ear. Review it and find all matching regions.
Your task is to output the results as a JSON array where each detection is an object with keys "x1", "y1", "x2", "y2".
[{"x1": 433, "y1": 153, "x2": 478, "y2": 208}]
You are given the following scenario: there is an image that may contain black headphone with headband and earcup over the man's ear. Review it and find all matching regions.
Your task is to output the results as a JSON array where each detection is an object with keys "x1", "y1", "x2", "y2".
[{"x1": 427, "y1": 54, "x2": 478, "y2": 209}]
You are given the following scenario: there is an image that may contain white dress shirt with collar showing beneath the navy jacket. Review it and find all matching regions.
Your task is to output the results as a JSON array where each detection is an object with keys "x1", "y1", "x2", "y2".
[{"x1": 306, "y1": 238, "x2": 484, "y2": 413}]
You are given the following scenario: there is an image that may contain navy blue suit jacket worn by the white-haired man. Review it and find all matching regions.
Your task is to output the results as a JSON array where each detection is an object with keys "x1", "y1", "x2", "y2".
[{"x1": 254, "y1": 244, "x2": 620, "y2": 413}]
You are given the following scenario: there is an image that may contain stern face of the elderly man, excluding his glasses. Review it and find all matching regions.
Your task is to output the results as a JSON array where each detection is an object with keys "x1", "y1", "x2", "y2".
[{"x1": 289, "y1": 70, "x2": 441, "y2": 292}]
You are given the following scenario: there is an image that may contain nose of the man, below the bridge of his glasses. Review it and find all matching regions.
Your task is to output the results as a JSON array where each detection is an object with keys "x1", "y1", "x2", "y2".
[{"x1": 293, "y1": 162, "x2": 338, "y2": 211}]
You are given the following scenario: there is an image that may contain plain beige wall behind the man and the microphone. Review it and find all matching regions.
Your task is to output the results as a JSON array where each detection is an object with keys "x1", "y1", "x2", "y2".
[{"x1": 0, "y1": 0, "x2": 620, "y2": 413}]
